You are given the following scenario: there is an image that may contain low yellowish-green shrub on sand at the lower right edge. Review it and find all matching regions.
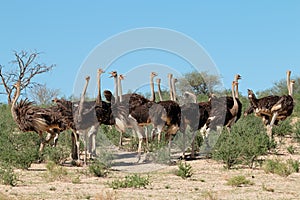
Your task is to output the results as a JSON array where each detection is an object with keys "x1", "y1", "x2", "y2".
[{"x1": 263, "y1": 159, "x2": 299, "y2": 177}]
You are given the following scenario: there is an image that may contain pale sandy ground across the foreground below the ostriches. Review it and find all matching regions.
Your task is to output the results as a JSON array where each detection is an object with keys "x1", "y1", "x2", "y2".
[{"x1": 0, "y1": 138, "x2": 300, "y2": 200}]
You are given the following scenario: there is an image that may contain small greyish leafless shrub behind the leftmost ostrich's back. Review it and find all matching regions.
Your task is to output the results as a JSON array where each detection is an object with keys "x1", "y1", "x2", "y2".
[{"x1": 29, "y1": 84, "x2": 59, "y2": 105}]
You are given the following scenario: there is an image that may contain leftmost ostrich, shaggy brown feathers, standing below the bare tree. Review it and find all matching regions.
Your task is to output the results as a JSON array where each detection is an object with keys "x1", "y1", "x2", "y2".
[{"x1": 11, "y1": 82, "x2": 64, "y2": 152}]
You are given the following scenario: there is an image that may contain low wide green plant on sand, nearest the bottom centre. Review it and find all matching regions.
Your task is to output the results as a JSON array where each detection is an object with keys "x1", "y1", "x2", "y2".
[{"x1": 109, "y1": 174, "x2": 150, "y2": 189}]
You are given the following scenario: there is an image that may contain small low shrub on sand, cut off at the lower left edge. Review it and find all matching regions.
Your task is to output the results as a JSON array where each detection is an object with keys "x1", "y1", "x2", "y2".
[{"x1": 0, "y1": 163, "x2": 18, "y2": 186}]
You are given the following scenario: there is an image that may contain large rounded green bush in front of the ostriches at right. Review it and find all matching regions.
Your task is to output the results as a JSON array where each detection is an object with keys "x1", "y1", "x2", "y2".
[{"x1": 213, "y1": 116, "x2": 271, "y2": 169}]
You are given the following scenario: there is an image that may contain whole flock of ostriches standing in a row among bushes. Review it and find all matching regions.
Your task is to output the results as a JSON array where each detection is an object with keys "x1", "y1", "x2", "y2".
[{"x1": 11, "y1": 69, "x2": 295, "y2": 163}]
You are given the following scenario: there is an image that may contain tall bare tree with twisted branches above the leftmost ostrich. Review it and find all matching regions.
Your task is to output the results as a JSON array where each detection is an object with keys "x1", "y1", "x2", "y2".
[{"x1": 0, "y1": 51, "x2": 54, "y2": 104}]
